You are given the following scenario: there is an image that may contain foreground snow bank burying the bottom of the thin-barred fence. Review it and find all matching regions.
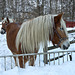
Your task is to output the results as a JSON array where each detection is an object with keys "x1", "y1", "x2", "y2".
[{"x1": 0, "y1": 61, "x2": 75, "y2": 75}]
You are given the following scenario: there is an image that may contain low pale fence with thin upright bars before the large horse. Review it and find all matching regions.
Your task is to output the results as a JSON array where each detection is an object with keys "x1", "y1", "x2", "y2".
[{"x1": 0, "y1": 50, "x2": 75, "y2": 71}]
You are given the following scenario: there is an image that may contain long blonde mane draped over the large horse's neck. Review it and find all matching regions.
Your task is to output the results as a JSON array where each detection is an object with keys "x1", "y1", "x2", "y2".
[{"x1": 16, "y1": 14, "x2": 66, "y2": 53}]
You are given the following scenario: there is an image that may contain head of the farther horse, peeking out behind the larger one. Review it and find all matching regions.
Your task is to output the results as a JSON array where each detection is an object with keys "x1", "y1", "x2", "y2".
[{"x1": 1, "y1": 17, "x2": 14, "y2": 34}]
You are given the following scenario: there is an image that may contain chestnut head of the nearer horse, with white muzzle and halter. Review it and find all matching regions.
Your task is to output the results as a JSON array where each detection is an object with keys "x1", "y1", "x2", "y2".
[{"x1": 52, "y1": 13, "x2": 70, "y2": 49}]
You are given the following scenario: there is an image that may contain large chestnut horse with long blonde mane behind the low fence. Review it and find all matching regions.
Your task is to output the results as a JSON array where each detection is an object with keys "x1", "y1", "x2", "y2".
[{"x1": 2, "y1": 13, "x2": 70, "y2": 68}]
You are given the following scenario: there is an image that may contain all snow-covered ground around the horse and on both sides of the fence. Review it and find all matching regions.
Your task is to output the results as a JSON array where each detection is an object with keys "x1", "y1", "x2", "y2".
[{"x1": 0, "y1": 23, "x2": 75, "y2": 75}]
